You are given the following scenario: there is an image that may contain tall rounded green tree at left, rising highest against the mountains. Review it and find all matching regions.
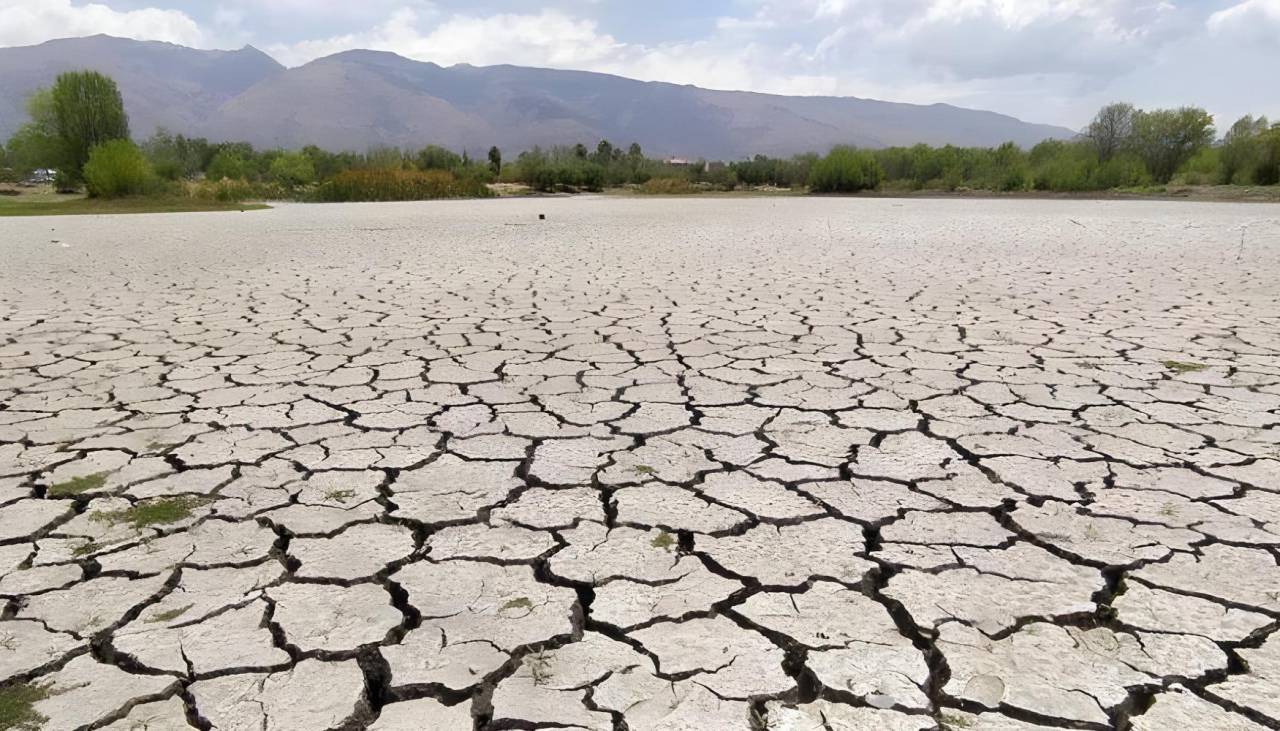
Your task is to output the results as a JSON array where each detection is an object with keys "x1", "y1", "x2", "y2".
[{"x1": 48, "y1": 70, "x2": 129, "y2": 179}]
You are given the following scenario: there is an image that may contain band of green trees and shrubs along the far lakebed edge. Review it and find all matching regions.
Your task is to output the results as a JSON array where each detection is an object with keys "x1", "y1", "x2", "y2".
[{"x1": 0, "y1": 72, "x2": 1280, "y2": 200}]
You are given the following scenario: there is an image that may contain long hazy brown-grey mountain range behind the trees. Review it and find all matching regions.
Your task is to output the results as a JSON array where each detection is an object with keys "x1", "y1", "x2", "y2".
[{"x1": 0, "y1": 36, "x2": 1074, "y2": 159}]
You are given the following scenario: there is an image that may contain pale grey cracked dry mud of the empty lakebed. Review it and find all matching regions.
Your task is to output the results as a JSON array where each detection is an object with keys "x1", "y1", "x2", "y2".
[{"x1": 0, "y1": 198, "x2": 1280, "y2": 731}]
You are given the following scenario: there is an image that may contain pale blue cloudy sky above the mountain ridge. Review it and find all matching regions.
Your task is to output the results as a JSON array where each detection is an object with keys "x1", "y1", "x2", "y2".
[{"x1": 0, "y1": 0, "x2": 1280, "y2": 129}]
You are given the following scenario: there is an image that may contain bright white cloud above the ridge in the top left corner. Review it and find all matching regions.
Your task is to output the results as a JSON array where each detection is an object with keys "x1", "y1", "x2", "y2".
[{"x1": 0, "y1": 0, "x2": 205, "y2": 46}]
